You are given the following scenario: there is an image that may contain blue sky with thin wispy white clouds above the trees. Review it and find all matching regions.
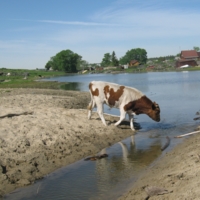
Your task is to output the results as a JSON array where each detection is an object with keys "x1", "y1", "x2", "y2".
[{"x1": 0, "y1": 0, "x2": 200, "y2": 69}]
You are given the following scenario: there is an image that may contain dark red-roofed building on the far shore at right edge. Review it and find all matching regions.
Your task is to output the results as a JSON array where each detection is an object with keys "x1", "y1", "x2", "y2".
[{"x1": 176, "y1": 50, "x2": 199, "y2": 68}]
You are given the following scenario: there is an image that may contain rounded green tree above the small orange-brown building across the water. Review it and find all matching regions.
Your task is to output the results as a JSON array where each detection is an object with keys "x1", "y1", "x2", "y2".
[{"x1": 119, "y1": 48, "x2": 147, "y2": 65}]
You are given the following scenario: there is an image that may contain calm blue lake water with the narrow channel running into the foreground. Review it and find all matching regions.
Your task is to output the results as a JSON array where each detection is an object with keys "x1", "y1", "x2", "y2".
[{"x1": 4, "y1": 71, "x2": 200, "y2": 200}]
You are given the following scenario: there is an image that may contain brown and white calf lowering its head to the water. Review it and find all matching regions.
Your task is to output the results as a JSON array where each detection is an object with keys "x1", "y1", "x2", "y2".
[{"x1": 88, "y1": 81, "x2": 160, "y2": 131}]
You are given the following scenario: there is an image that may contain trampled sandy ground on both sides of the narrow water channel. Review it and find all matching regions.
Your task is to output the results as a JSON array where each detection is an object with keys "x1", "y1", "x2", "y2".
[{"x1": 0, "y1": 89, "x2": 200, "y2": 200}]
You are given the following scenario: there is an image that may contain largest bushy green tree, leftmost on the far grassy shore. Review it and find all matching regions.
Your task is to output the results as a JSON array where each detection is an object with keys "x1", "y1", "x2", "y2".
[{"x1": 45, "y1": 49, "x2": 82, "y2": 72}]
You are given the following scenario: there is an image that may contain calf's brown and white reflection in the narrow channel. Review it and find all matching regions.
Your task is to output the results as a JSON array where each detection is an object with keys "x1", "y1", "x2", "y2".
[{"x1": 90, "y1": 136, "x2": 161, "y2": 200}]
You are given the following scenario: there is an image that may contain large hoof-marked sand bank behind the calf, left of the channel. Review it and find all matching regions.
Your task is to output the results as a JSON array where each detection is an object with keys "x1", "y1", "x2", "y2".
[{"x1": 0, "y1": 89, "x2": 133, "y2": 196}]
